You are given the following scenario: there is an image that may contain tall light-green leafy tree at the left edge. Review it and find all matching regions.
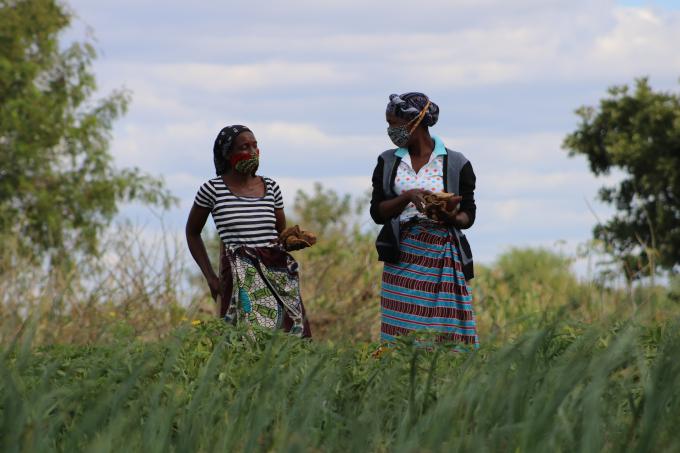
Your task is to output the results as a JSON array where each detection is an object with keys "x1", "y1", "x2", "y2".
[{"x1": 0, "y1": 0, "x2": 174, "y2": 258}]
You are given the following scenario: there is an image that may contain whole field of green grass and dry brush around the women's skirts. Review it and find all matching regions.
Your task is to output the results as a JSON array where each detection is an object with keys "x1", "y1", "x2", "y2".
[{"x1": 0, "y1": 185, "x2": 680, "y2": 452}]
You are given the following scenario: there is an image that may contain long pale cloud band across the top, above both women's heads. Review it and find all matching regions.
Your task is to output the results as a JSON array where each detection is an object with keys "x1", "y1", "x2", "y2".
[{"x1": 89, "y1": 2, "x2": 680, "y2": 96}]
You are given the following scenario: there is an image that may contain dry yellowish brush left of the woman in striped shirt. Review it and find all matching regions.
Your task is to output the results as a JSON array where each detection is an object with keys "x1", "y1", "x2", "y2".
[{"x1": 0, "y1": 223, "x2": 189, "y2": 343}]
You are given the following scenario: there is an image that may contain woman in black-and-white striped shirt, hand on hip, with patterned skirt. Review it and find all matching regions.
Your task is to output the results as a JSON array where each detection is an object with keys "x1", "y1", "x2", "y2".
[{"x1": 186, "y1": 125, "x2": 311, "y2": 337}]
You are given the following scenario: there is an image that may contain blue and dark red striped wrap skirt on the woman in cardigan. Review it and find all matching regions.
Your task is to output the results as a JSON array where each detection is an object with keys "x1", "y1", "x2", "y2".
[{"x1": 380, "y1": 221, "x2": 479, "y2": 349}]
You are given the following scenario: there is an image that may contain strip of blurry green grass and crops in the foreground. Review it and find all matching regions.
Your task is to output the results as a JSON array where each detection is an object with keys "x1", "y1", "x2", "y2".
[{"x1": 0, "y1": 320, "x2": 680, "y2": 452}]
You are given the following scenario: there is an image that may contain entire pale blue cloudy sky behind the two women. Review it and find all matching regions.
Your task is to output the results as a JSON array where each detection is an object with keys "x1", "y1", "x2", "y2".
[{"x1": 68, "y1": 0, "x2": 680, "y2": 268}]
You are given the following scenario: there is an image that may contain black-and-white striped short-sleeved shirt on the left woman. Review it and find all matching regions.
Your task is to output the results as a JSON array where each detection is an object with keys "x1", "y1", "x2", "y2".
[{"x1": 194, "y1": 176, "x2": 283, "y2": 247}]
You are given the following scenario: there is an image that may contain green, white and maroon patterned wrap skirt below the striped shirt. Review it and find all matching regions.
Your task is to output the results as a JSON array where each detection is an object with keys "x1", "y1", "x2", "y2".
[{"x1": 220, "y1": 246, "x2": 312, "y2": 338}]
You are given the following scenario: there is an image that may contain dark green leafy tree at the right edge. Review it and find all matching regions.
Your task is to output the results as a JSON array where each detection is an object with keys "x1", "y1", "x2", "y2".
[{"x1": 563, "y1": 78, "x2": 680, "y2": 279}]
